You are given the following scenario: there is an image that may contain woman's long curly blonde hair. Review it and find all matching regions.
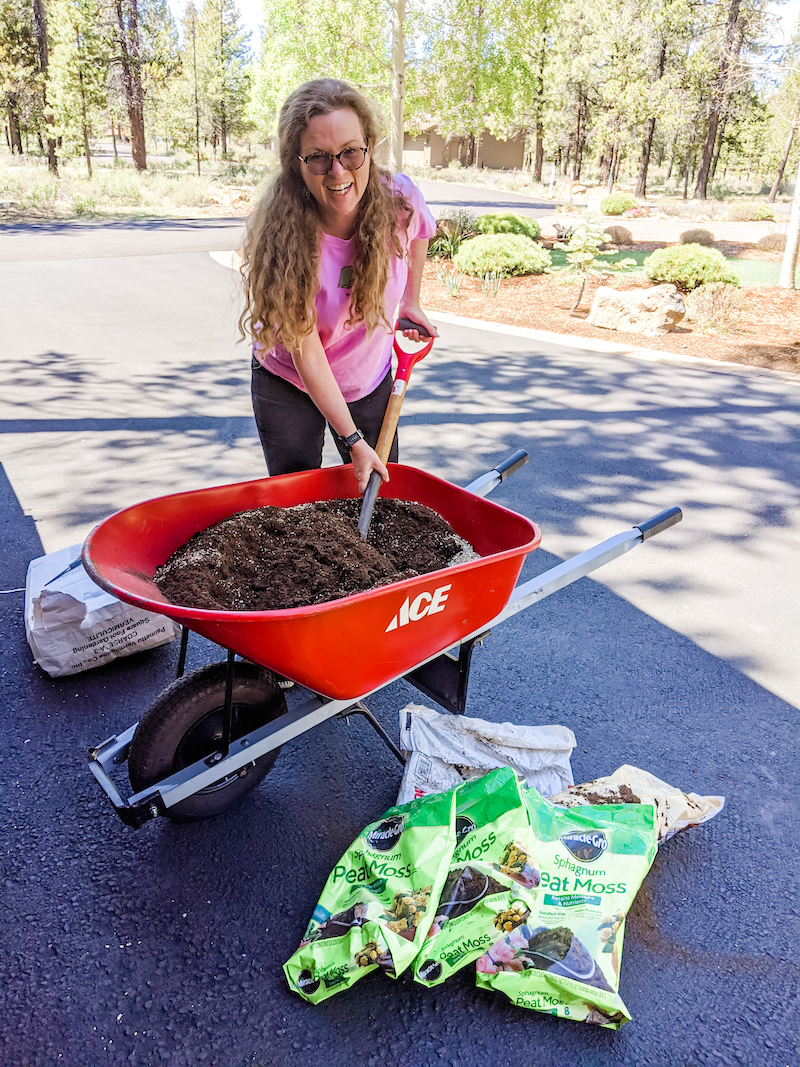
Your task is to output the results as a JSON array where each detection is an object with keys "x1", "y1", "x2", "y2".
[{"x1": 239, "y1": 78, "x2": 414, "y2": 352}]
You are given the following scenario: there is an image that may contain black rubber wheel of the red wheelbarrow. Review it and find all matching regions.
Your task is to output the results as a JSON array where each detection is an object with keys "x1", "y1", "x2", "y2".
[{"x1": 128, "y1": 663, "x2": 286, "y2": 823}]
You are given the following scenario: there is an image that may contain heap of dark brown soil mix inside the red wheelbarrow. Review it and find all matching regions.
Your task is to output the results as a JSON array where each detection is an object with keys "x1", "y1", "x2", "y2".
[{"x1": 155, "y1": 497, "x2": 478, "y2": 611}]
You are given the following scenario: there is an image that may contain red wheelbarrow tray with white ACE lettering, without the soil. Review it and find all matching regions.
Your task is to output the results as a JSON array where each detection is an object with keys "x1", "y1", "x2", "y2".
[{"x1": 83, "y1": 463, "x2": 541, "y2": 699}]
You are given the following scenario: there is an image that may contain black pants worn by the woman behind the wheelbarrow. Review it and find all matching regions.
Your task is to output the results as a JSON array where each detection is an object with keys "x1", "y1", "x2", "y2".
[{"x1": 252, "y1": 359, "x2": 398, "y2": 475}]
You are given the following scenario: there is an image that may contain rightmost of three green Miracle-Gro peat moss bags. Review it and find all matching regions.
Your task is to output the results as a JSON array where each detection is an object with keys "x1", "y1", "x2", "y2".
[{"x1": 476, "y1": 790, "x2": 657, "y2": 1030}]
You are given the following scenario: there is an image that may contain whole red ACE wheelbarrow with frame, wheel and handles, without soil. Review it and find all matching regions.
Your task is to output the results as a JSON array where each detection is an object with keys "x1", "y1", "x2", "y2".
[{"x1": 83, "y1": 451, "x2": 682, "y2": 827}]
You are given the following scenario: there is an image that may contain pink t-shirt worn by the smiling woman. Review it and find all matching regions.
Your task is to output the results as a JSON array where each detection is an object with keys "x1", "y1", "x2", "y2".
[{"x1": 253, "y1": 174, "x2": 436, "y2": 403}]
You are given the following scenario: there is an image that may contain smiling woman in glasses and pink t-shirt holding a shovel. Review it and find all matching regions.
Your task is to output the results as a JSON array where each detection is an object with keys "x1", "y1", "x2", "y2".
[{"x1": 240, "y1": 78, "x2": 437, "y2": 492}]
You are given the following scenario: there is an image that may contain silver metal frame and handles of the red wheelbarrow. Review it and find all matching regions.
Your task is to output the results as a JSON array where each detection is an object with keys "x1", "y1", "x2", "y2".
[{"x1": 89, "y1": 451, "x2": 683, "y2": 827}]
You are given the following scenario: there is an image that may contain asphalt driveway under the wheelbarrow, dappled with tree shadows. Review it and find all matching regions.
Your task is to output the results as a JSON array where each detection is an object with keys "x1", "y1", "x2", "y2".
[{"x1": 0, "y1": 201, "x2": 800, "y2": 1067}]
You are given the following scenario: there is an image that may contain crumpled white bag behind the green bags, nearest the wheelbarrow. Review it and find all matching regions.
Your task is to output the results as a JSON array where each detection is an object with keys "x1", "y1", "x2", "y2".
[{"x1": 397, "y1": 704, "x2": 575, "y2": 803}]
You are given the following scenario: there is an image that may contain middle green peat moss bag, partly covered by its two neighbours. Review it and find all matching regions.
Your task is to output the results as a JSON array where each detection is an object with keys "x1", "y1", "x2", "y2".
[{"x1": 414, "y1": 767, "x2": 540, "y2": 986}]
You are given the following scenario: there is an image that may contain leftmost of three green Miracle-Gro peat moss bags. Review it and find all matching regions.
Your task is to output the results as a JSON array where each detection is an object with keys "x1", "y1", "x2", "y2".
[{"x1": 284, "y1": 790, "x2": 455, "y2": 1004}]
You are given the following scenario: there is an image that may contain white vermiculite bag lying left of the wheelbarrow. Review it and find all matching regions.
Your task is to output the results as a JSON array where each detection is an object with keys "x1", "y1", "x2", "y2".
[{"x1": 25, "y1": 544, "x2": 180, "y2": 678}]
